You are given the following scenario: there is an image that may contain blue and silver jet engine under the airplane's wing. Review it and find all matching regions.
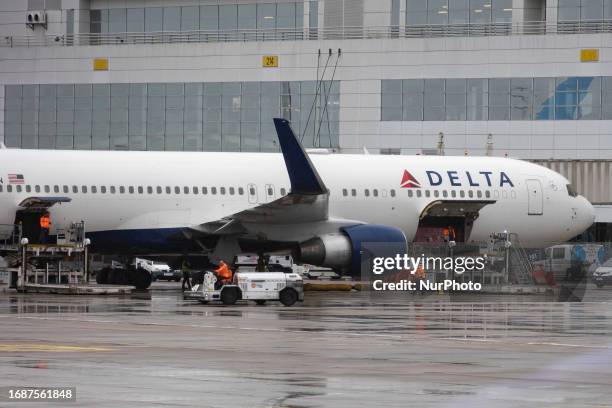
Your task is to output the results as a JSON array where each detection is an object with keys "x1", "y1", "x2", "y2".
[{"x1": 297, "y1": 224, "x2": 407, "y2": 276}]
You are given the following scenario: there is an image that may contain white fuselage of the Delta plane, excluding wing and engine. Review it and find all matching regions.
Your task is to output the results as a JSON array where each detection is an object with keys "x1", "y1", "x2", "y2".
[{"x1": 0, "y1": 149, "x2": 594, "y2": 244}]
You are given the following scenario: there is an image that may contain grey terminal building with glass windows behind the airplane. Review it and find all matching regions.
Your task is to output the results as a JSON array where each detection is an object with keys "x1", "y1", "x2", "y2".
[{"x1": 0, "y1": 0, "x2": 612, "y2": 241}]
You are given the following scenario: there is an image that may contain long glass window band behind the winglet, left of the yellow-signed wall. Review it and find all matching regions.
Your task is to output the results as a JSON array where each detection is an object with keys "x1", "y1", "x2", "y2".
[{"x1": 4, "y1": 81, "x2": 340, "y2": 151}]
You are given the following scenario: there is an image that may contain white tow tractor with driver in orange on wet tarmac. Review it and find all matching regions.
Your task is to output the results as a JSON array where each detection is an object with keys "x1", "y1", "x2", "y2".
[{"x1": 184, "y1": 271, "x2": 304, "y2": 306}]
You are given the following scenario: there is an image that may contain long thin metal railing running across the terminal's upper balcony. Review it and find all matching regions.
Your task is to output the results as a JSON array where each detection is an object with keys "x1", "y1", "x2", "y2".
[{"x1": 0, "y1": 20, "x2": 612, "y2": 47}]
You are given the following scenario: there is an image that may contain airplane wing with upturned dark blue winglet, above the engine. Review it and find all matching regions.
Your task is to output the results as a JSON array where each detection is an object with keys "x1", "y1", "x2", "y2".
[{"x1": 194, "y1": 118, "x2": 360, "y2": 235}]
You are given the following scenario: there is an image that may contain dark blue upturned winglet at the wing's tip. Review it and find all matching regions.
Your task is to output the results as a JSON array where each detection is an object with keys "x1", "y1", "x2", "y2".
[{"x1": 274, "y1": 118, "x2": 328, "y2": 194}]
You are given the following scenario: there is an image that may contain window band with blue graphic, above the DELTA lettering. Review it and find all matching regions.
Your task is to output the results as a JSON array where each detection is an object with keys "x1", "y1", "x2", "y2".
[{"x1": 381, "y1": 77, "x2": 612, "y2": 121}]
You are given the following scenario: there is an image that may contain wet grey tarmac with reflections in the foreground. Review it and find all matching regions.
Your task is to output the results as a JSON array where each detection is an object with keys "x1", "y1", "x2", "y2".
[{"x1": 0, "y1": 283, "x2": 612, "y2": 408}]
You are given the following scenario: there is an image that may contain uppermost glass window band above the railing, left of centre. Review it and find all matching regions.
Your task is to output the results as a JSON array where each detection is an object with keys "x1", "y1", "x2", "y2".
[{"x1": 90, "y1": 1, "x2": 306, "y2": 33}]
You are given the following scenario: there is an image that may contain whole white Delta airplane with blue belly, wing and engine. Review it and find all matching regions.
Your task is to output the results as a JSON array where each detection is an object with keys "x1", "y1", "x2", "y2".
[{"x1": 0, "y1": 119, "x2": 594, "y2": 274}]
